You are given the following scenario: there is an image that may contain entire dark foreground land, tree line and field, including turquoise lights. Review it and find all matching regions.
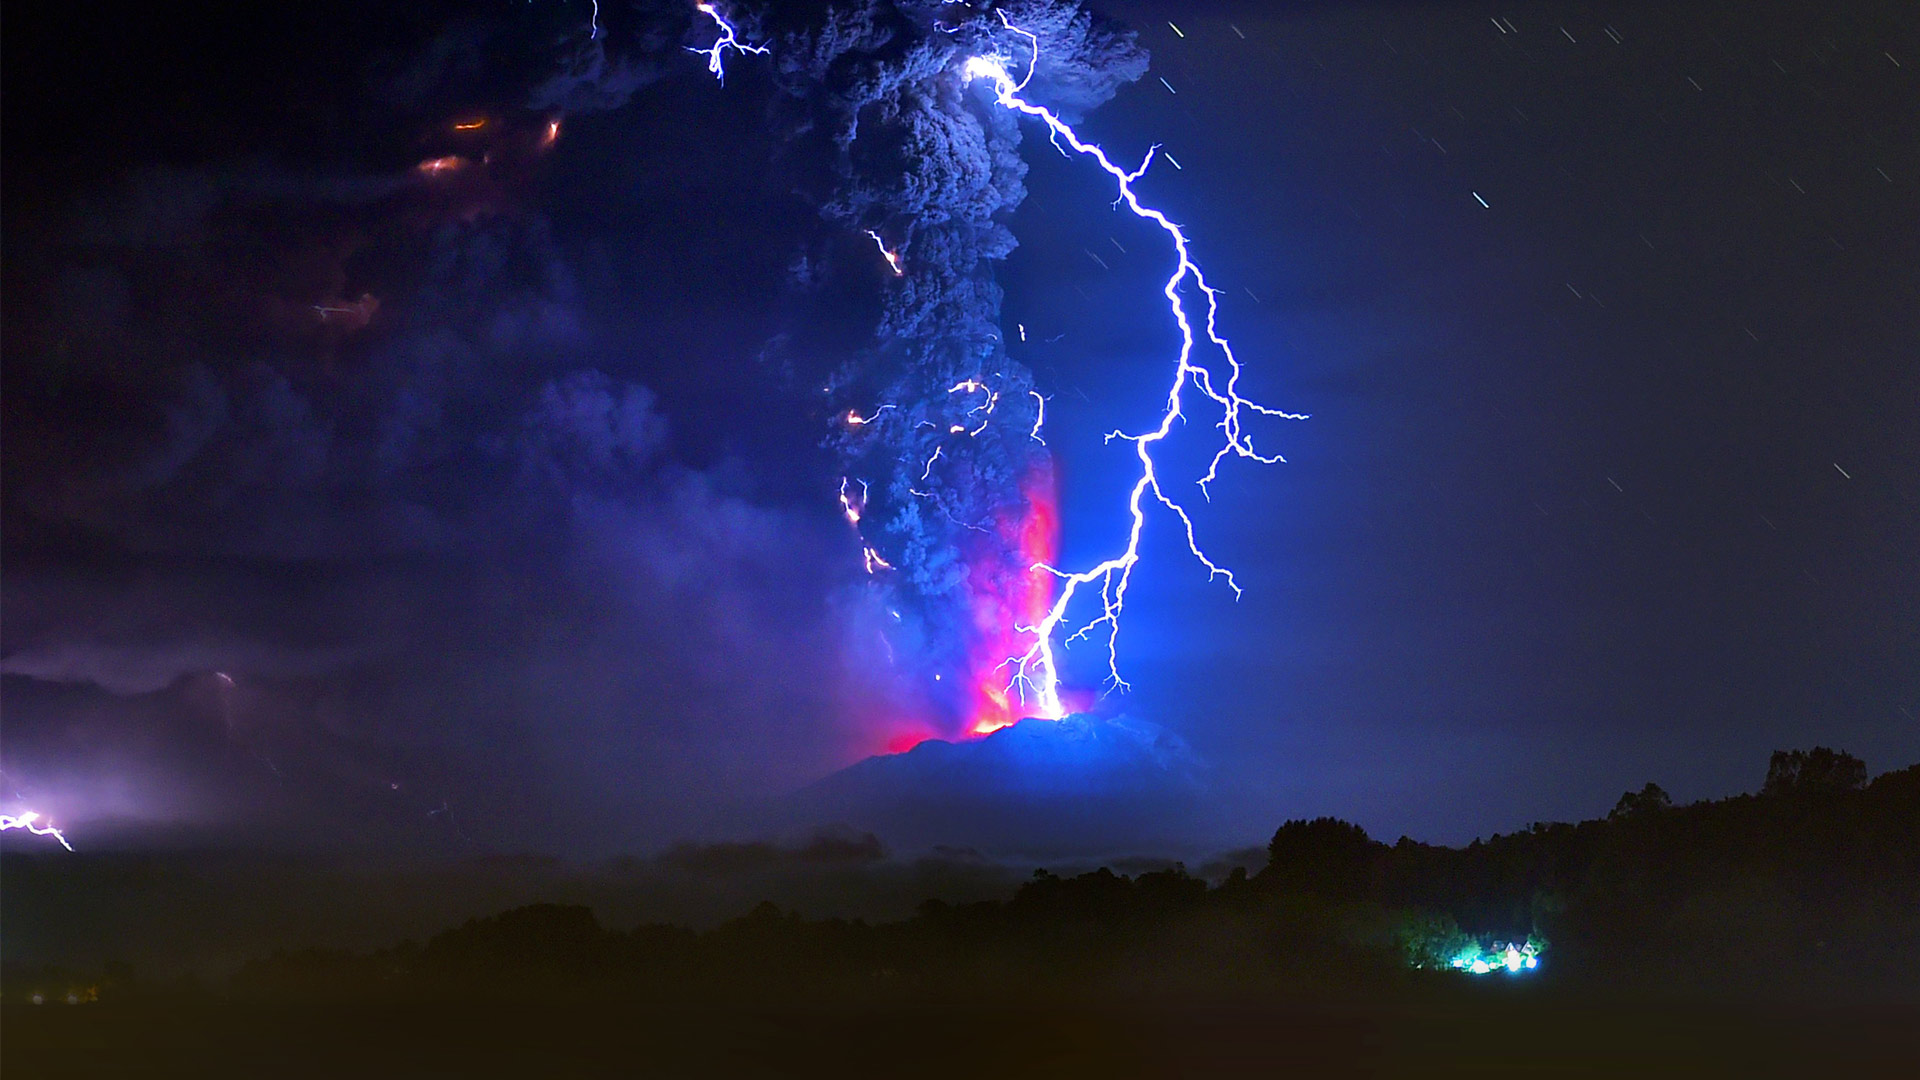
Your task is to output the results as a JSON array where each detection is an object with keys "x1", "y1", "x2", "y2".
[{"x1": 0, "y1": 751, "x2": 1920, "y2": 1078}]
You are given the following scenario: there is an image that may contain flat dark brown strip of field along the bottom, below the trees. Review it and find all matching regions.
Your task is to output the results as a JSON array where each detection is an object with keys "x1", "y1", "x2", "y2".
[{"x1": 4, "y1": 986, "x2": 1920, "y2": 1080}]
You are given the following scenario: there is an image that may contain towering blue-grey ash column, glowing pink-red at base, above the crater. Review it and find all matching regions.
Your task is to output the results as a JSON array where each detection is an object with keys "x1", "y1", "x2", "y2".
[{"x1": 774, "y1": 0, "x2": 1146, "y2": 734}]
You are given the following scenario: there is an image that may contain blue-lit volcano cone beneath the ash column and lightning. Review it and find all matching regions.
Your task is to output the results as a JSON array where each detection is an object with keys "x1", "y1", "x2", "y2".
[{"x1": 785, "y1": 715, "x2": 1204, "y2": 857}]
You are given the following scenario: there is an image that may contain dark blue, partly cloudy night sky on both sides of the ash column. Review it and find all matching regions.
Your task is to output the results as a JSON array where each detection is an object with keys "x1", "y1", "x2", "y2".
[{"x1": 0, "y1": 0, "x2": 1920, "y2": 855}]
